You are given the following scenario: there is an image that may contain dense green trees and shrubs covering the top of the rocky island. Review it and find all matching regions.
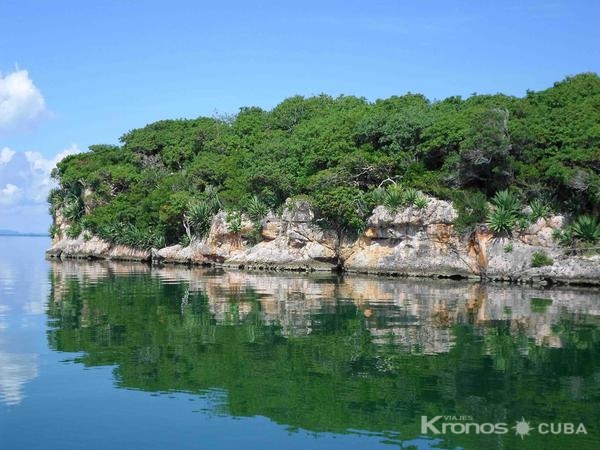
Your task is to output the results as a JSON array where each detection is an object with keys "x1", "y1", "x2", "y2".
[{"x1": 50, "y1": 74, "x2": 600, "y2": 247}]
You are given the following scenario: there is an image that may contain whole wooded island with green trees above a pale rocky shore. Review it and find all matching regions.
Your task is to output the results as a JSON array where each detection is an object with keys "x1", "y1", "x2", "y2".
[{"x1": 47, "y1": 73, "x2": 600, "y2": 285}]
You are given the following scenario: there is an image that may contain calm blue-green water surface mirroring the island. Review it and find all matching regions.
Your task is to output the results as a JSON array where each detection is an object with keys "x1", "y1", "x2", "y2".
[{"x1": 0, "y1": 237, "x2": 600, "y2": 449}]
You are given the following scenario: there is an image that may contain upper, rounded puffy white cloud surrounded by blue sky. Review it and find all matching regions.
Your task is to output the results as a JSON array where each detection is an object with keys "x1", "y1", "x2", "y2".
[{"x1": 0, "y1": 70, "x2": 47, "y2": 136}]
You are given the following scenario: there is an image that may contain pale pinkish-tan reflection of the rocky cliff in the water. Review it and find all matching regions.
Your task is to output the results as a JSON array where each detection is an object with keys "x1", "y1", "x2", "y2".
[{"x1": 52, "y1": 261, "x2": 600, "y2": 354}]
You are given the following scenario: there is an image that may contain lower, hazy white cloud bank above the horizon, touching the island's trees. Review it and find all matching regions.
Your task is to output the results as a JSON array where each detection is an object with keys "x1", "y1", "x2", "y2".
[{"x1": 0, "y1": 144, "x2": 80, "y2": 231}]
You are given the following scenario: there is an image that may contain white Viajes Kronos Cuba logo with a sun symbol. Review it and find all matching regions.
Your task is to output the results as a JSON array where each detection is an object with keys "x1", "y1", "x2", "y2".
[{"x1": 421, "y1": 416, "x2": 587, "y2": 439}]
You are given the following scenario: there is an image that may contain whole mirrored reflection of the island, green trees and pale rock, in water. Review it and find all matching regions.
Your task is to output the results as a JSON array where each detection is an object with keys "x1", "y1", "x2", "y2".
[{"x1": 48, "y1": 262, "x2": 600, "y2": 448}]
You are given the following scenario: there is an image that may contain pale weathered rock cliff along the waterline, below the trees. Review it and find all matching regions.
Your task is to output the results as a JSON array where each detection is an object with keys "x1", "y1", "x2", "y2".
[{"x1": 47, "y1": 198, "x2": 600, "y2": 285}]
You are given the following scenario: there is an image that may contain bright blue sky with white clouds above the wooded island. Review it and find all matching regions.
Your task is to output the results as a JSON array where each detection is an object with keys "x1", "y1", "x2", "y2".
[{"x1": 0, "y1": 0, "x2": 600, "y2": 231}]
